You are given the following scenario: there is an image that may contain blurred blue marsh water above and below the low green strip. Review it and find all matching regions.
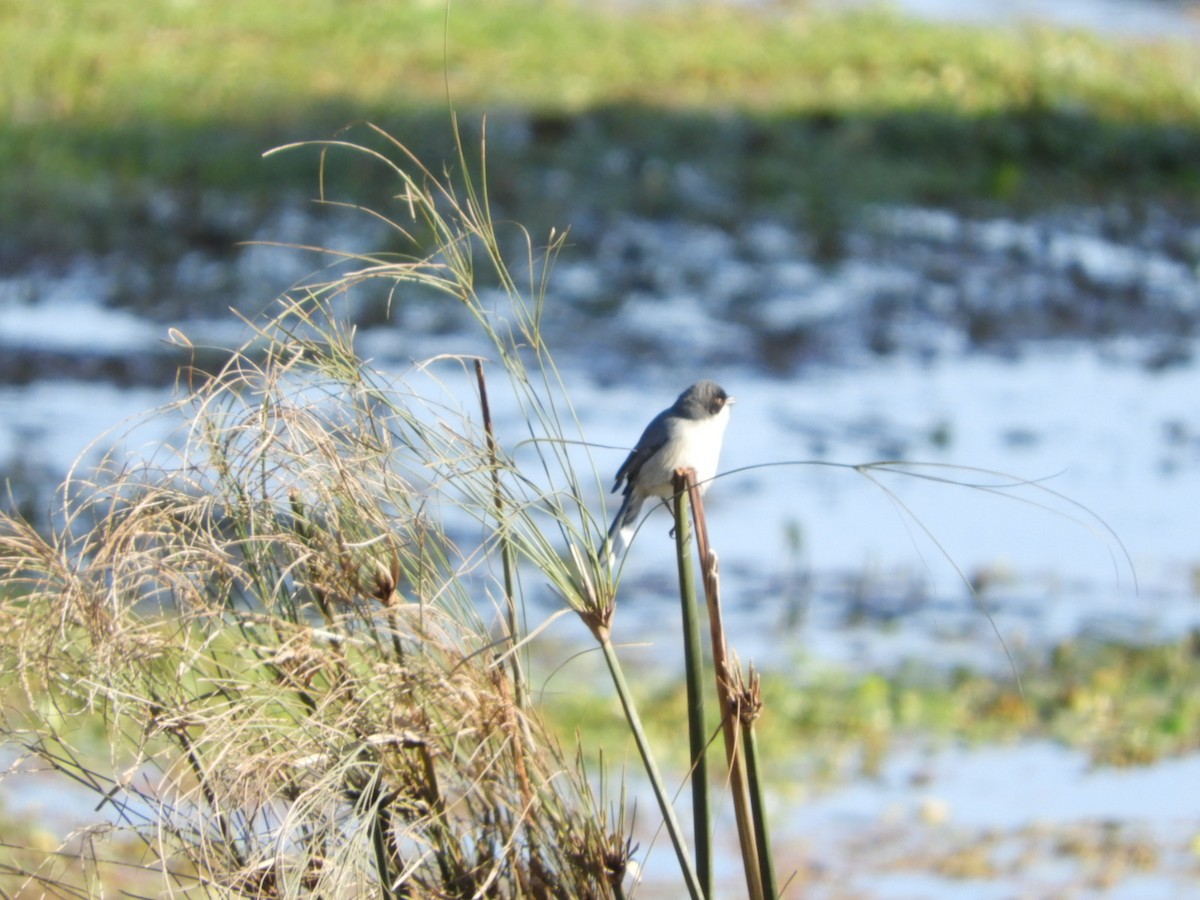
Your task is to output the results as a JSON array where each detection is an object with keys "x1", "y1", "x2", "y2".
[{"x1": 0, "y1": 200, "x2": 1200, "y2": 898}]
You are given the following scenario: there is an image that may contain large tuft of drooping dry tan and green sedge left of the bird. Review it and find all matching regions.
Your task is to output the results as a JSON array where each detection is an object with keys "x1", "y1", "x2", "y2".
[{"x1": 0, "y1": 125, "x2": 632, "y2": 898}]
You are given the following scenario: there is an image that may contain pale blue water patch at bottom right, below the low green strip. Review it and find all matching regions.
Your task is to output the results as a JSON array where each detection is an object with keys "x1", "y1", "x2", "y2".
[{"x1": 638, "y1": 742, "x2": 1200, "y2": 900}]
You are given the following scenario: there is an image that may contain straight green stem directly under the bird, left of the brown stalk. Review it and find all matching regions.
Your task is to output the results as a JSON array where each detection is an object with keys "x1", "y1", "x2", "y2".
[{"x1": 674, "y1": 473, "x2": 713, "y2": 896}]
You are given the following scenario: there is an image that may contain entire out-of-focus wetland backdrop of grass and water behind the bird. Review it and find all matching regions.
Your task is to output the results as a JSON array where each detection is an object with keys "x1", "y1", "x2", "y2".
[{"x1": 0, "y1": 0, "x2": 1200, "y2": 898}]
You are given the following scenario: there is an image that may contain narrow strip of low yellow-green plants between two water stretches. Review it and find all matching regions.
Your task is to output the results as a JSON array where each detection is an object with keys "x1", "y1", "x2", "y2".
[{"x1": 545, "y1": 632, "x2": 1200, "y2": 784}]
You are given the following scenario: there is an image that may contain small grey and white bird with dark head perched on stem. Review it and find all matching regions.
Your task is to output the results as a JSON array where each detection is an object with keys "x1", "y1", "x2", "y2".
[{"x1": 605, "y1": 380, "x2": 733, "y2": 562}]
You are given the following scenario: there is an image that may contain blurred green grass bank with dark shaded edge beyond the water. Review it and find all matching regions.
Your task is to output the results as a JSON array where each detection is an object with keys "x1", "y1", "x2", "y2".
[{"x1": 0, "y1": 0, "x2": 1200, "y2": 259}]
